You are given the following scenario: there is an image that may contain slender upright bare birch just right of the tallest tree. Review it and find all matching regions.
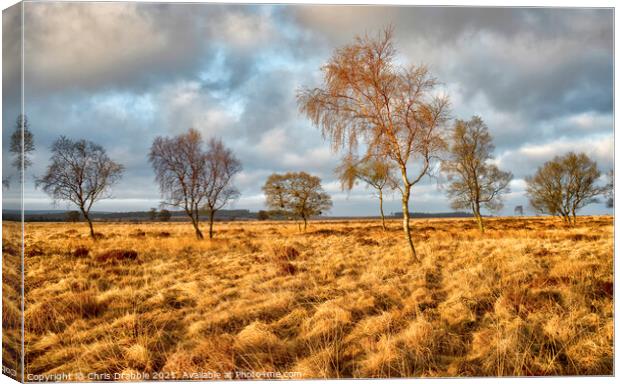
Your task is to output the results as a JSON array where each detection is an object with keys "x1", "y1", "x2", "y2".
[{"x1": 442, "y1": 116, "x2": 512, "y2": 232}]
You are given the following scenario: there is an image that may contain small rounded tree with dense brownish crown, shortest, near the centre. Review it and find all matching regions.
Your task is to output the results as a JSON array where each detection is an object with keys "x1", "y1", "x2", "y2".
[{"x1": 263, "y1": 172, "x2": 332, "y2": 231}]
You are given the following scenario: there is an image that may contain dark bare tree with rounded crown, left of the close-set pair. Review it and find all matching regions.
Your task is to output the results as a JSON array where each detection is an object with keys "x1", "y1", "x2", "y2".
[{"x1": 36, "y1": 136, "x2": 123, "y2": 238}]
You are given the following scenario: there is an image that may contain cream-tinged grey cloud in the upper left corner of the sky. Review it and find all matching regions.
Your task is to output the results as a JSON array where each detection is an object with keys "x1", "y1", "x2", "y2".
[{"x1": 24, "y1": 2, "x2": 200, "y2": 92}]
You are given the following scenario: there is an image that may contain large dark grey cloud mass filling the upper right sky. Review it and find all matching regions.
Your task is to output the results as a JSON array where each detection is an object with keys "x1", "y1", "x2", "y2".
[{"x1": 291, "y1": 6, "x2": 613, "y2": 150}]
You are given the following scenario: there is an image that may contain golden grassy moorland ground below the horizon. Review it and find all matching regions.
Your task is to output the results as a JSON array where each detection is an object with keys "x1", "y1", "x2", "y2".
[{"x1": 3, "y1": 217, "x2": 614, "y2": 380}]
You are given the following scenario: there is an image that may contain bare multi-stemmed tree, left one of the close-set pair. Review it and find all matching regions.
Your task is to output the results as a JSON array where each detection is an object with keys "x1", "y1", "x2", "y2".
[{"x1": 149, "y1": 129, "x2": 208, "y2": 239}]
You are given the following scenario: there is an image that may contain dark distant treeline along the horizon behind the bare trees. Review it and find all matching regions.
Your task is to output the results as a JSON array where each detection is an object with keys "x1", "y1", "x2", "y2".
[{"x1": 2, "y1": 209, "x2": 472, "y2": 222}]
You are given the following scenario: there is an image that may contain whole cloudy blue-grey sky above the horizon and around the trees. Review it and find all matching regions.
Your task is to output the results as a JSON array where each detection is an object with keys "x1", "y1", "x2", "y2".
[{"x1": 2, "y1": 2, "x2": 614, "y2": 216}]
